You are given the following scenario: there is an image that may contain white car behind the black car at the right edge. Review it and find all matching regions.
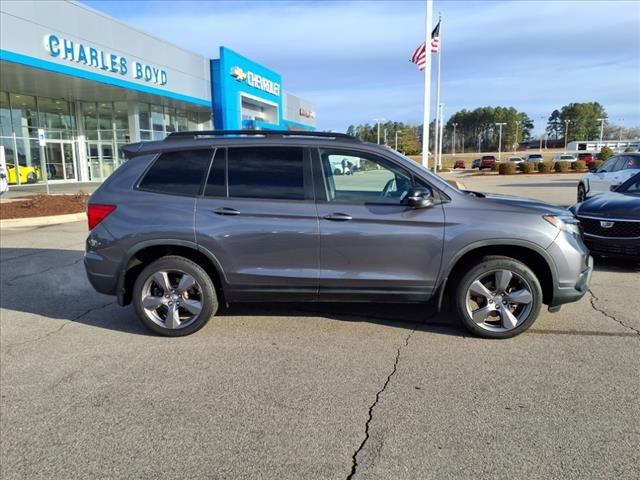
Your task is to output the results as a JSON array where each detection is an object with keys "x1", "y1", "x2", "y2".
[{"x1": 578, "y1": 153, "x2": 640, "y2": 202}]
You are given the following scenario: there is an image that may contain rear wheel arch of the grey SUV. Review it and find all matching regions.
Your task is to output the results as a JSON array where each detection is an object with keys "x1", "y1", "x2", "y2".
[{"x1": 117, "y1": 239, "x2": 227, "y2": 305}]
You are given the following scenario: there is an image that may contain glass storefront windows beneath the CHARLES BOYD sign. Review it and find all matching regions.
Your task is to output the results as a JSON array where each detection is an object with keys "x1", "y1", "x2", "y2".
[{"x1": 0, "y1": 91, "x2": 212, "y2": 184}]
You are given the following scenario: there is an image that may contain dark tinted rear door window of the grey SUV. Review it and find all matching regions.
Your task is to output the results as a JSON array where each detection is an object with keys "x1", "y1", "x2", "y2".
[{"x1": 227, "y1": 147, "x2": 305, "y2": 200}]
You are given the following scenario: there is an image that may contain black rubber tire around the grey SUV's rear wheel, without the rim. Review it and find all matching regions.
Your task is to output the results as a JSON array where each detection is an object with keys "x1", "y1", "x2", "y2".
[{"x1": 133, "y1": 255, "x2": 219, "y2": 337}]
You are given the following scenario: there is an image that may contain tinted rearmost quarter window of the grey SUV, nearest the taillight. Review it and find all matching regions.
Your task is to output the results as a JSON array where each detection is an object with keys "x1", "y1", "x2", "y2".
[{"x1": 138, "y1": 149, "x2": 213, "y2": 195}]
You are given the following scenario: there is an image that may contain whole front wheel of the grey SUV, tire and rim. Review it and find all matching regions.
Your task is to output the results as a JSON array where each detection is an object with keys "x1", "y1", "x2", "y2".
[{"x1": 455, "y1": 256, "x2": 542, "y2": 338}]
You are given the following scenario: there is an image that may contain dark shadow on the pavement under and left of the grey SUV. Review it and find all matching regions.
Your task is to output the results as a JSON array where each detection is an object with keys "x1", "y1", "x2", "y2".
[{"x1": 0, "y1": 248, "x2": 466, "y2": 336}]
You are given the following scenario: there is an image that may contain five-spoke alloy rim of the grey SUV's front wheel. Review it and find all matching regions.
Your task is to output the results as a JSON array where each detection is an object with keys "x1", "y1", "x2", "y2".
[{"x1": 466, "y1": 269, "x2": 533, "y2": 332}]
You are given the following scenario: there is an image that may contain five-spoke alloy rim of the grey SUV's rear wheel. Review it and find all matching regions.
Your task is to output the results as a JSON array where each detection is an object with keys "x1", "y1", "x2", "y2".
[{"x1": 141, "y1": 270, "x2": 203, "y2": 330}]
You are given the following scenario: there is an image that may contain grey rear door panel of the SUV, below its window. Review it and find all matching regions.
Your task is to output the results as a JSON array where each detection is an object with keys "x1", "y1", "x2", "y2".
[{"x1": 196, "y1": 198, "x2": 319, "y2": 298}]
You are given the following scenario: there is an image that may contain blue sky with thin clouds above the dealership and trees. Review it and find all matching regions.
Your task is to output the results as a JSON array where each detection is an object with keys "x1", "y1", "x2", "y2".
[{"x1": 85, "y1": 0, "x2": 640, "y2": 130}]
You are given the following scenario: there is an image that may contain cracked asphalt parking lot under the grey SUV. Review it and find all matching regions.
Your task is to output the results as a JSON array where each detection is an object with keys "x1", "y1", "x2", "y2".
[{"x1": 0, "y1": 177, "x2": 640, "y2": 479}]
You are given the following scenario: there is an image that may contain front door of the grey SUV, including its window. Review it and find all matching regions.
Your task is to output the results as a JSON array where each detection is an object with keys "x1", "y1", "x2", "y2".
[{"x1": 316, "y1": 150, "x2": 444, "y2": 300}]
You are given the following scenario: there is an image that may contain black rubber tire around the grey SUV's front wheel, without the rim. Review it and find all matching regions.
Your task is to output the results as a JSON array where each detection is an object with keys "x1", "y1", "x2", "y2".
[{"x1": 453, "y1": 255, "x2": 542, "y2": 338}]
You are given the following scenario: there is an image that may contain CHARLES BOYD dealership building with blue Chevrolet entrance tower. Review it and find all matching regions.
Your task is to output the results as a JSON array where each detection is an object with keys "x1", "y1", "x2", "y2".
[{"x1": 0, "y1": 0, "x2": 316, "y2": 184}]
